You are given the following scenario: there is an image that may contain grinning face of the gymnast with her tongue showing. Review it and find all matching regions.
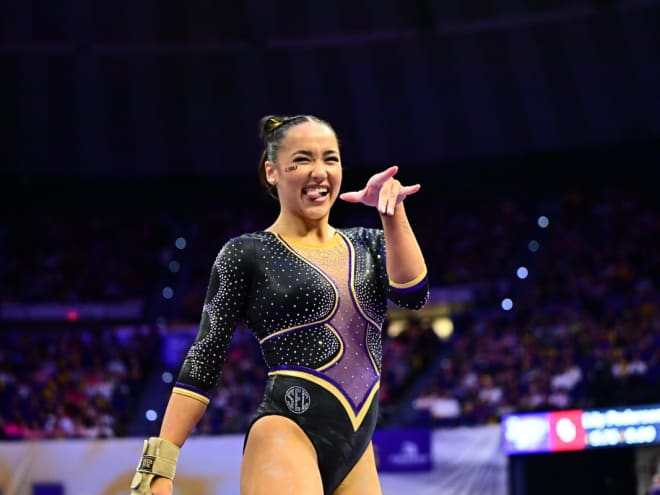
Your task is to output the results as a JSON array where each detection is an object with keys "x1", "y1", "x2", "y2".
[{"x1": 265, "y1": 121, "x2": 342, "y2": 225}]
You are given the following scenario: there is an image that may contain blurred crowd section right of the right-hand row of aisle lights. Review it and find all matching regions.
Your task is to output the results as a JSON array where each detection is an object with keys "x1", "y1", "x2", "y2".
[{"x1": 414, "y1": 188, "x2": 660, "y2": 425}]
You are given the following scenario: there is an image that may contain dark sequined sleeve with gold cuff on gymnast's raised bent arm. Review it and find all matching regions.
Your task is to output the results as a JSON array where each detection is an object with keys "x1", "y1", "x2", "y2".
[{"x1": 363, "y1": 229, "x2": 429, "y2": 309}]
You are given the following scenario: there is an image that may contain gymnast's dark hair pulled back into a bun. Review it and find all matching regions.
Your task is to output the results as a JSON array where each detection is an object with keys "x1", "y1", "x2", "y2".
[{"x1": 257, "y1": 115, "x2": 335, "y2": 199}]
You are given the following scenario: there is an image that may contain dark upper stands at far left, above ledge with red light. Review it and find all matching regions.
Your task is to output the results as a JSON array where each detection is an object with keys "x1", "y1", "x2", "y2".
[{"x1": 0, "y1": 211, "x2": 175, "y2": 302}]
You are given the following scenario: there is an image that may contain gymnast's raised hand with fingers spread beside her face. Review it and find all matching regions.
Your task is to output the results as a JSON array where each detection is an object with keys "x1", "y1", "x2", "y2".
[{"x1": 339, "y1": 165, "x2": 421, "y2": 216}]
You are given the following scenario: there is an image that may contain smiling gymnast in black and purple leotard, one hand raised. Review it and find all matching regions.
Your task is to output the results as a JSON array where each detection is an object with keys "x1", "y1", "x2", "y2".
[{"x1": 131, "y1": 115, "x2": 428, "y2": 495}]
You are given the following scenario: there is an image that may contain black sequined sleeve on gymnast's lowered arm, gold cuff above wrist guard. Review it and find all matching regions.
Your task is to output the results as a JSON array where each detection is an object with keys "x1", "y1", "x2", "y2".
[{"x1": 173, "y1": 237, "x2": 254, "y2": 403}]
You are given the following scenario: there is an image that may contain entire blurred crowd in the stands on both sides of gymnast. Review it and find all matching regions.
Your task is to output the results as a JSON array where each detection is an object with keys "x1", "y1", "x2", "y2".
[{"x1": 0, "y1": 174, "x2": 660, "y2": 438}]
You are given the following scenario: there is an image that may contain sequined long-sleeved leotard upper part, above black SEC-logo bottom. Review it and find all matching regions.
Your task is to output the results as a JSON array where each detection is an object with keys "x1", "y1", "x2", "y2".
[{"x1": 174, "y1": 228, "x2": 429, "y2": 429}]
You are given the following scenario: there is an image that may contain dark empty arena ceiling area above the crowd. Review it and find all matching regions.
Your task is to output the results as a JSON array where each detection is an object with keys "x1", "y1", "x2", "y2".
[{"x1": 0, "y1": 0, "x2": 660, "y2": 208}]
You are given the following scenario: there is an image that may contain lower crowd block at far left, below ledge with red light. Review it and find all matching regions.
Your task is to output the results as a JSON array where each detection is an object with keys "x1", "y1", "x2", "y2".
[{"x1": 0, "y1": 325, "x2": 159, "y2": 440}]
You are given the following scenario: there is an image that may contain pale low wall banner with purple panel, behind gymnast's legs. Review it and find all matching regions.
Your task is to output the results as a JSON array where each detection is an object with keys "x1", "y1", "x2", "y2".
[{"x1": 0, "y1": 425, "x2": 507, "y2": 495}]
